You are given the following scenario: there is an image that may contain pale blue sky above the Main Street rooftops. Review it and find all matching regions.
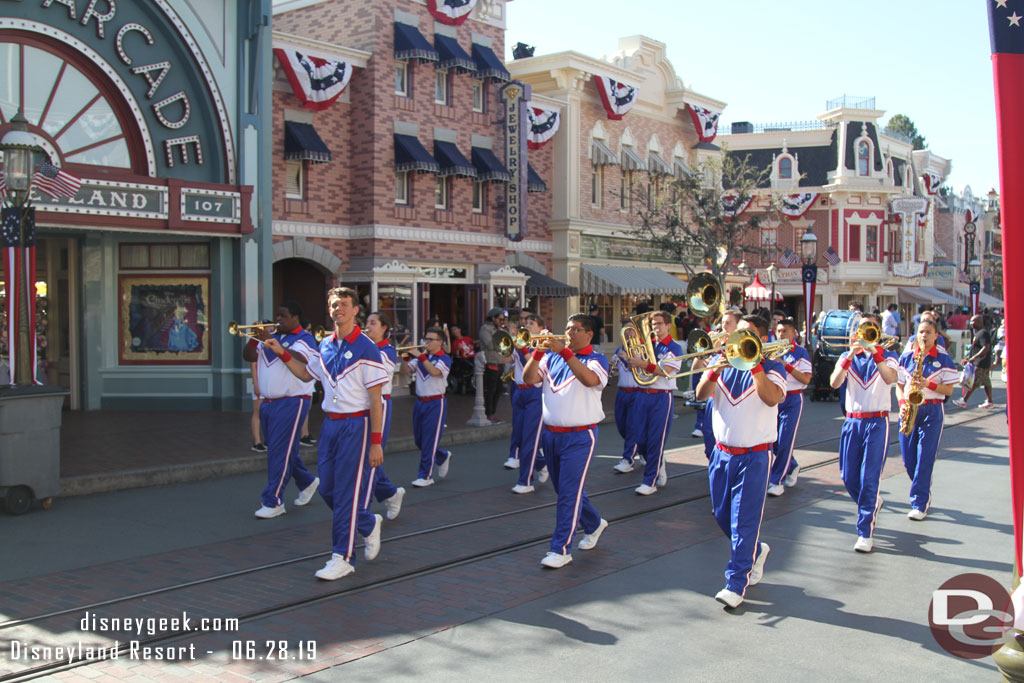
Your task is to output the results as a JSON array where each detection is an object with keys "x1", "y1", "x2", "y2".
[{"x1": 506, "y1": 0, "x2": 998, "y2": 196}]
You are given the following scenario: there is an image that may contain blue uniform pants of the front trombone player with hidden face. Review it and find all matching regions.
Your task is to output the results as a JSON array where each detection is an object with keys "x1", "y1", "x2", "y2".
[{"x1": 708, "y1": 446, "x2": 771, "y2": 595}]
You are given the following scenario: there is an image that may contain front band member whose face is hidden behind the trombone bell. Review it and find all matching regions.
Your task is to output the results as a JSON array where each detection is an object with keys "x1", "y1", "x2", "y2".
[{"x1": 697, "y1": 315, "x2": 786, "y2": 607}]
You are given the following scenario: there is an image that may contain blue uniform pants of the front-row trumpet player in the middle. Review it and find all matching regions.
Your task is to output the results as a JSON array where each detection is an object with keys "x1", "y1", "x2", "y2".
[{"x1": 541, "y1": 427, "x2": 601, "y2": 555}]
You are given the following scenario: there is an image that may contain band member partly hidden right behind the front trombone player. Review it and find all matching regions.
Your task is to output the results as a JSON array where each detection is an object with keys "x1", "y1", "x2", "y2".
[{"x1": 768, "y1": 317, "x2": 812, "y2": 496}]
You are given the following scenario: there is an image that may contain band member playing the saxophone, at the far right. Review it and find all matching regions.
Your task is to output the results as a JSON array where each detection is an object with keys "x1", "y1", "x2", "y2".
[{"x1": 896, "y1": 317, "x2": 959, "y2": 521}]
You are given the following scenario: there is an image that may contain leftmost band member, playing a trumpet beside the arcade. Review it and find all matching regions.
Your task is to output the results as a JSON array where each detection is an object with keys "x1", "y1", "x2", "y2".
[{"x1": 242, "y1": 300, "x2": 319, "y2": 519}]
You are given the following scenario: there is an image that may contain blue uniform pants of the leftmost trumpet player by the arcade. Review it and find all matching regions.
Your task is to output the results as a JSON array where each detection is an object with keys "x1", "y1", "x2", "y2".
[{"x1": 259, "y1": 396, "x2": 315, "y2": 508}]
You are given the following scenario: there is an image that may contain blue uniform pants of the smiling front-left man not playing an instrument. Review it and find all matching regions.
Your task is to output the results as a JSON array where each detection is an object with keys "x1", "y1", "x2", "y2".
[{"x1": 316, "y1": 416, "x2": 376, "y2": 564}]
